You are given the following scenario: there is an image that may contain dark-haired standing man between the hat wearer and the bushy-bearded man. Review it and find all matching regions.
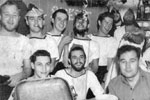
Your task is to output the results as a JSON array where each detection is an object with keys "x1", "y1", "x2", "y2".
[{"x1": 47, "y1": 9, "x2": 72, "y2": 73}]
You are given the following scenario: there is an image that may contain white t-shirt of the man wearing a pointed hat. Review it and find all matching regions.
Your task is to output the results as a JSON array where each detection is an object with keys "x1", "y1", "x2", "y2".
[{"x1": 30, "y1": 35, "x2": 59, "y2": 59}]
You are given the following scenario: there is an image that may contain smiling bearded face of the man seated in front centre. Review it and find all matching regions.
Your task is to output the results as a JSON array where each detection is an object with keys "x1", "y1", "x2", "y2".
[{"x1": 70, "y1": 50, "x2": 85, "y2": 72}]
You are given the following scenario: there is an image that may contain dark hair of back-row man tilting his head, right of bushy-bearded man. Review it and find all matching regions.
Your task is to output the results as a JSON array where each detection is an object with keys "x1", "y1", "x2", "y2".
[{"x1": 97, "y1": 12, "x2": 114, "y2": 30}]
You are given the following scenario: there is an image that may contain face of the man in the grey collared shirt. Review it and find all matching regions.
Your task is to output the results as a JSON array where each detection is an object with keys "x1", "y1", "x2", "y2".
[{"x1": 119, "y1": 50, "x2": 139, "y2": 78}]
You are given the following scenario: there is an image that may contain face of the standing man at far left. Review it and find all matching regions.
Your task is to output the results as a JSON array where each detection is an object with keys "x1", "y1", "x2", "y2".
[{"x1": 0, "y1": 5, "x2": 20, "y2": 32}]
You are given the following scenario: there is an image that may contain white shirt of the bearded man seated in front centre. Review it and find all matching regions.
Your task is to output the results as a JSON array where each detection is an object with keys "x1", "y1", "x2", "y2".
[{"x1": 55, "y1": 69, "x2": 104, "y2": 100}]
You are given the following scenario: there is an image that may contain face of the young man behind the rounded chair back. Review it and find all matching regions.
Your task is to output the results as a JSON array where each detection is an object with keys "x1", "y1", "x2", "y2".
[{"x1": 31, "y1": 56, "x2": 53, "y2": 78}]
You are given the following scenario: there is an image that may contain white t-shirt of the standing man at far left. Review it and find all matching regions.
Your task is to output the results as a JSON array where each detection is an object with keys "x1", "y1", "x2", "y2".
[{"x1": 0, "y1": 34, "x2": 31, "y2": 75}]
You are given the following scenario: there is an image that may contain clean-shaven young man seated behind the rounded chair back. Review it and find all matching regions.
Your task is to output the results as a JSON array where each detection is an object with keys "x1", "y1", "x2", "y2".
[{"x1": 8, "y1": 50, "x2": 53, "y2": 100}]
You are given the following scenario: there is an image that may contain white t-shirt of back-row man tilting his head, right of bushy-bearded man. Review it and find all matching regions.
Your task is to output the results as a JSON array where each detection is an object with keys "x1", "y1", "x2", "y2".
[{"x1": 90, "y1": 35, "x2": 118, "y2": 66}]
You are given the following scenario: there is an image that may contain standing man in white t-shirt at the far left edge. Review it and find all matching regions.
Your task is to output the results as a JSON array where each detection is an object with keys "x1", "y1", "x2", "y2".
[{"x1": 0, "y1": 1, "x2": 31, "y2": 100}]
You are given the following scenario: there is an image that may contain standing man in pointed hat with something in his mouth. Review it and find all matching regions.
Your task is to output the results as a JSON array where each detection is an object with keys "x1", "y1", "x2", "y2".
[{"x1": 25, "y1": 4, "x2": 59, "y2": 73}]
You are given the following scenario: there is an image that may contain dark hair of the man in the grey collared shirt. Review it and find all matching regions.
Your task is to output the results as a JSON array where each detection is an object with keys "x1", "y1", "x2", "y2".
[{"x1": 117, "y1": 45, "x2": 141, "y2": 59}]
